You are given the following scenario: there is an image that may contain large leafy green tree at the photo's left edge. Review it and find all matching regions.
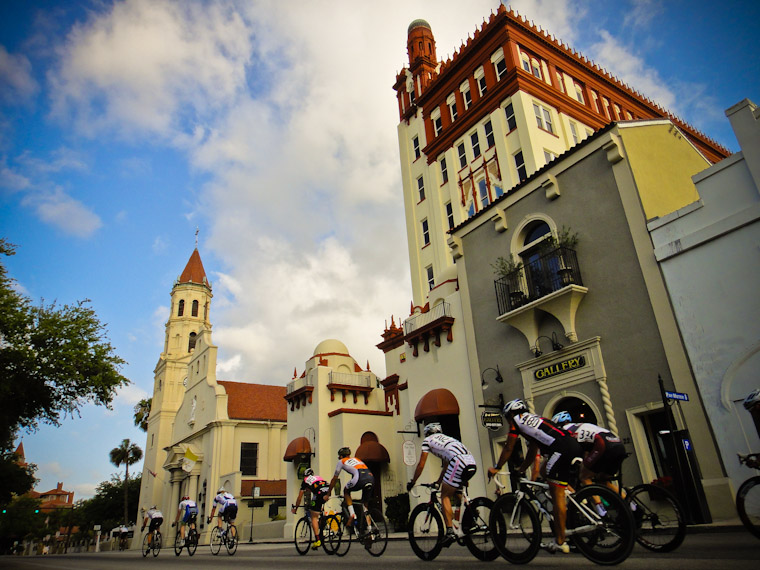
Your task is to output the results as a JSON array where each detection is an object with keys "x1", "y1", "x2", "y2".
[{"x1": 0, "y1": 238, "x2": 129, "y2": 451}]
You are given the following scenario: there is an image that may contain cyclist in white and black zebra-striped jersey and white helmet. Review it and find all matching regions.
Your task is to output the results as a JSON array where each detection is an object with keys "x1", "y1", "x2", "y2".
[{"x1": 406, "y1": 422, "x2": 478, "y2": 547}]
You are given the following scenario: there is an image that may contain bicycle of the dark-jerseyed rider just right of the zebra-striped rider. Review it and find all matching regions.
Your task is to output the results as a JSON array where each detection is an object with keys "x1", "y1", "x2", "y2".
[{"x1": 489, "y1": 466, "x2": 636, "y2": 565}]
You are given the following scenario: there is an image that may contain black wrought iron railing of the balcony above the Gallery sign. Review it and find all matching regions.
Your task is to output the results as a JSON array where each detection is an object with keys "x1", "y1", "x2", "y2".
[{"x1": 494, "y1": 247, "x2": 583, "y2": 315}]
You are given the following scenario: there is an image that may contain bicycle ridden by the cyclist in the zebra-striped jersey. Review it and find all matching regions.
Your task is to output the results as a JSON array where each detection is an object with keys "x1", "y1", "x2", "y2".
[{"x1": 409, "y1": 483, "x2": 499, "y2": 562}]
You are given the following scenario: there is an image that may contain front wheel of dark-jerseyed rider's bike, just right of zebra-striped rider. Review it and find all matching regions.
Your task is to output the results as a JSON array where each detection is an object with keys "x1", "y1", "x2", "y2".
[{"x1": 488, "y1": 493, "x2": 541, "y2": 564}]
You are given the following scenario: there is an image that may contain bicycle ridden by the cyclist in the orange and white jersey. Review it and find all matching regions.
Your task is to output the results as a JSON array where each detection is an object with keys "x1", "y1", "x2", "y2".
[{"x1": 322, "y1": 492, "x2": 388, "y2": 556}]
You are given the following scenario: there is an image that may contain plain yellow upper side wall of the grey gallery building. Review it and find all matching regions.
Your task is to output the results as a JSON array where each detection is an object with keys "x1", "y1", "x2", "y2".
[{"x1": 619, "y1": 123, "x2": 710, "y2": 220}]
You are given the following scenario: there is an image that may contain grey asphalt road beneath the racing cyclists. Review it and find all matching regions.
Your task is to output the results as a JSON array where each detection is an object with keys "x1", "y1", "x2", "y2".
[{"x1": 0, "y1": 531, "x2": 760, "y2": 570}]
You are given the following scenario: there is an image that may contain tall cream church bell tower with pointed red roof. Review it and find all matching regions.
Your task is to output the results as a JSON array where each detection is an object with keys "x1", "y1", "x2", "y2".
[{"x1": 137, "y1": 247, "x2": 213, "y2": 520}]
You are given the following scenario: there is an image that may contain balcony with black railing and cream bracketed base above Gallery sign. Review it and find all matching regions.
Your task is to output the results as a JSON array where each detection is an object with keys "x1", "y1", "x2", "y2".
[{"x1": 494, "y1": 247, "x2": 588, "y2": 346}]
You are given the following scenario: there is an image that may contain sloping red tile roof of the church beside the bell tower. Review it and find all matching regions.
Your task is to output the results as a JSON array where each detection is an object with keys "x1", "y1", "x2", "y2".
[{"x1": 218, "y1": 380, "x2": 288, "y2": 422}]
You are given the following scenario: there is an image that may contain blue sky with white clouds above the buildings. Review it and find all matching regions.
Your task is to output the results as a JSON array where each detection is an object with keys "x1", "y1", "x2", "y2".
[{"x1": 0, "y1": 0, "x2": 760, "y2": 498}]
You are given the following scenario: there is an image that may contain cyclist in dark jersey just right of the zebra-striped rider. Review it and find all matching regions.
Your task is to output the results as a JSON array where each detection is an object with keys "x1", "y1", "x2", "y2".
[{"x1": 488, "y1": 399, "x2": 583, "y2": 554}]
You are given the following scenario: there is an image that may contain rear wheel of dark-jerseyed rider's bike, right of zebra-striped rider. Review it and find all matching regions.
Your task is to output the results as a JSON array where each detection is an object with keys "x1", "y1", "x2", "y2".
[{"x1": 567, "y1": 485, "x2": 636, "y2": 565}]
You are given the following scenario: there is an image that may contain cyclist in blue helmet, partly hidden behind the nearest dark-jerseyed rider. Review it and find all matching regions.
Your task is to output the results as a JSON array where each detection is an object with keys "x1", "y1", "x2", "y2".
[{"x1": 552, "y1": 411, "x2": 626, "y2": 492}]
